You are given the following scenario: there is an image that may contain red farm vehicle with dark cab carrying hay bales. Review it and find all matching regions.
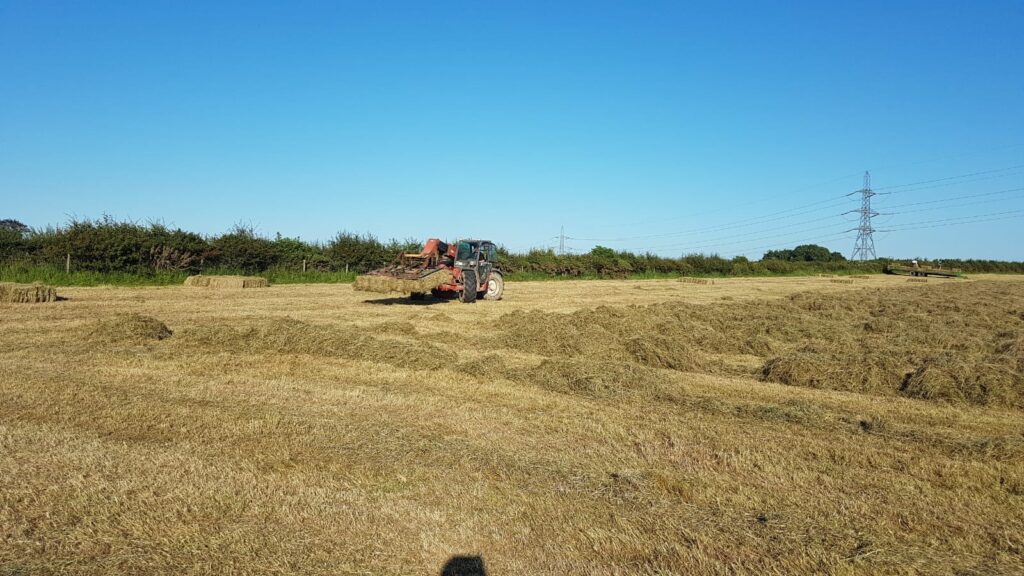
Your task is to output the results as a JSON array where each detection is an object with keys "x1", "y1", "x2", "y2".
[{"x1": 353, "y1": 238, "x2": 505, "y2": 302}]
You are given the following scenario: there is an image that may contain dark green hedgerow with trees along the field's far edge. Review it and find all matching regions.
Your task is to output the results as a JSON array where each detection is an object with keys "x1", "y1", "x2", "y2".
[{"x1": 0, "y1": 217, "x2": 1024, "y2": 278}]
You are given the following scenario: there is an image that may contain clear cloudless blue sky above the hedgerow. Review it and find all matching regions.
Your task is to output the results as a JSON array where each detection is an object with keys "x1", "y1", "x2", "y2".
[{"x1": 0, "y1": 0, "x2": 1024, "y2": 260}]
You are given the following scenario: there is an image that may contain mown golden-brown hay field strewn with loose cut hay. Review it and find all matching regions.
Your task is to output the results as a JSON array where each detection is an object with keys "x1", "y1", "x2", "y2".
[{"x1": 0, "y1": 277, "x2": 1024, "y2": 575}]
